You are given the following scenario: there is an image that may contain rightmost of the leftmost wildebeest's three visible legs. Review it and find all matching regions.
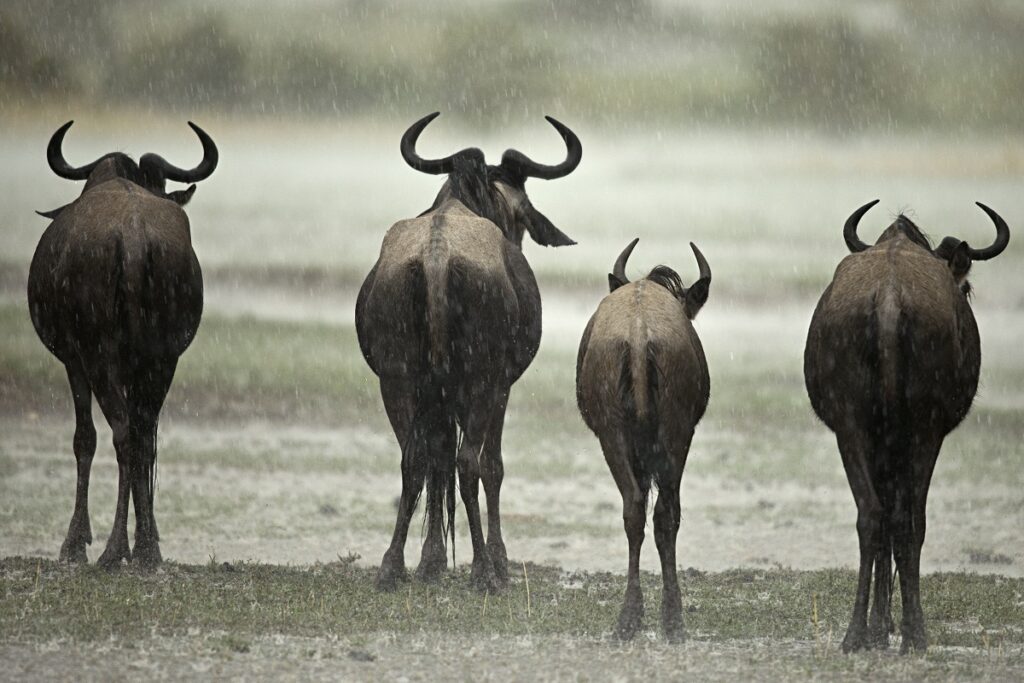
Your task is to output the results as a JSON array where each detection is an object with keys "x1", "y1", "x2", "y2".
[{"x1": 128, "y1": 358, "x2": 177, "y2": 568}]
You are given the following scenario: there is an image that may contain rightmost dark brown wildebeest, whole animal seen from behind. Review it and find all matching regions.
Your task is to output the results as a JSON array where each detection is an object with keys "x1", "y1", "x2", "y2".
[{"x1": 804, "y1": 200, "x2": 1010, "y2": 652}]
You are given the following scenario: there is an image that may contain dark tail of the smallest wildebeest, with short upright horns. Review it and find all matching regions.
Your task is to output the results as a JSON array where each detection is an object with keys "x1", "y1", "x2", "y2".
[{"x1": 618, "y1": 342, "x2": 668, "y2": 495}]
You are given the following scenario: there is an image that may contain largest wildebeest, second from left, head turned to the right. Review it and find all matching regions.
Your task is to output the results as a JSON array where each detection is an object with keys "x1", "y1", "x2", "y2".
[{"x1": 355, "y1": 114, "x2": 583, "y2": 590}]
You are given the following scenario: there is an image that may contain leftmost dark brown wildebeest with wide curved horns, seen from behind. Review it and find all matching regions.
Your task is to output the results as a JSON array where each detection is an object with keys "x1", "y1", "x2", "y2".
[{"x1": 29, "y1": 121, "x2": 217, "y2": 567}]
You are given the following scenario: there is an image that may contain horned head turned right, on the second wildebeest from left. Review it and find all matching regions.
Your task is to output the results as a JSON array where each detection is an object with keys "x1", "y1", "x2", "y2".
[{"x1": 401, "y1": 112, "x2": 583, "y2": 247}]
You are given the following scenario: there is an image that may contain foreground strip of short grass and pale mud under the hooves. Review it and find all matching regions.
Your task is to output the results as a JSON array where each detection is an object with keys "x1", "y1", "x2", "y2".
[{"x1": 0, "y1": 558, "x2": 1024, "y2": 679}]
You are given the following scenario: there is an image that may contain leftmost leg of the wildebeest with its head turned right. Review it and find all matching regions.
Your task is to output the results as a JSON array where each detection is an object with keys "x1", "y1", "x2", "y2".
[{"x1": 377, "y1": 379, "x2": 426, "y2": 591}]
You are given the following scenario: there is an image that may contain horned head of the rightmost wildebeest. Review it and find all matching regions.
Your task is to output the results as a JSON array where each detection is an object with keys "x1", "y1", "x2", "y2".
[{"x1": 843, "y1": 200, "x2": 1010, "y2": 294}]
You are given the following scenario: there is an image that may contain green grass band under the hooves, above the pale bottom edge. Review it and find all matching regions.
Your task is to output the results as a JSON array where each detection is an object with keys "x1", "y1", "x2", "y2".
[{"x1": 0, "y1": 558, "x2": 1024, "y2": 652}]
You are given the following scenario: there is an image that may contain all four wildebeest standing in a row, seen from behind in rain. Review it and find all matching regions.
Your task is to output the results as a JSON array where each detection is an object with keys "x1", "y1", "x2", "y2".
[{"x1": 28, "y1": 114, "x2": 1010, "y2": 651}]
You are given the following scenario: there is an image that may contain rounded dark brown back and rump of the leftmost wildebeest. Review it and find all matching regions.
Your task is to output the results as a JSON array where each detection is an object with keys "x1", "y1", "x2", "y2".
[{"x1": 29, "y1": 179, "x2": 203, "y2": 366}]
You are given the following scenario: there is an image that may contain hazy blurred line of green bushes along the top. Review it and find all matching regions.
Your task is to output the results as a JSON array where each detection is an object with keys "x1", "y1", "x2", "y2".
[{"x1": 0, "y1": 0, "x2": 1024, "y2": 133}]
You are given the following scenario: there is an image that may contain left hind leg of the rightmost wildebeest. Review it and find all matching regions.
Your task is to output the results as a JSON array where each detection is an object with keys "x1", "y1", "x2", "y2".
[{"x1": 837, "y1": 430, "x2": 882, "y2": 652}]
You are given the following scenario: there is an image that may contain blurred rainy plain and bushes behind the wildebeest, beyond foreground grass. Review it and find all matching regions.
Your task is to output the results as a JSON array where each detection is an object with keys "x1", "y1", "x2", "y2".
[{"x1": 0, "y1": 0, "x2": 1024, "y2": 574}]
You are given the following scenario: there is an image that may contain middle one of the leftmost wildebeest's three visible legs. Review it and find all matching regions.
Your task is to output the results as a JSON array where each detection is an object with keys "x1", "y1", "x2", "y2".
[{"x1": 90, "y1": 370, "x2": 133, "y2": 569}]
